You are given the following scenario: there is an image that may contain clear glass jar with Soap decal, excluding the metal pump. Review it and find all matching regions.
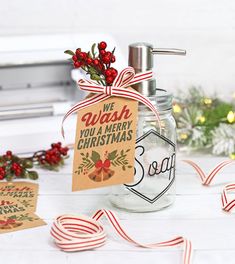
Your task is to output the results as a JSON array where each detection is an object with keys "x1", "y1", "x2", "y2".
[{"x1": 110, "y1": 90, "x2": 176, "y2": 212}]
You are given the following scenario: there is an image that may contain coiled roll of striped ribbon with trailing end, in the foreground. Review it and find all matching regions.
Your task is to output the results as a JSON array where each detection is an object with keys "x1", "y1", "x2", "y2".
[{"x1": 51, "y1": 209, "x2": 192, "y2": 264}]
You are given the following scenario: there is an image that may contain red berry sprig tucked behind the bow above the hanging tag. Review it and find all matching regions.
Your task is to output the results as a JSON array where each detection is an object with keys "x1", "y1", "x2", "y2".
[{"x1": 65, "y1": 41, "x2": 118, "y2": 86}]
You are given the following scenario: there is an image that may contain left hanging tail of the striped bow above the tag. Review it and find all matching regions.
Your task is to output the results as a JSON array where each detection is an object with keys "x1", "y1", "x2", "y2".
[{"x1": 61, "y1": 94, "x2": 110, "y2": 138}]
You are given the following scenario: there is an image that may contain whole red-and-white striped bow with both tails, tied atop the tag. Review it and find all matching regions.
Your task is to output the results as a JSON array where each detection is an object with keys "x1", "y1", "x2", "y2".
[{"x1": 62, "y1": 67, "x2": 161, "y2": 137}]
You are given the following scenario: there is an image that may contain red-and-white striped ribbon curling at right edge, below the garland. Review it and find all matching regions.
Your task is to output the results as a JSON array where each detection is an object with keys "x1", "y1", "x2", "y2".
[{"x1": 183, "y1": 160, "x2": 235, "y2": 212}]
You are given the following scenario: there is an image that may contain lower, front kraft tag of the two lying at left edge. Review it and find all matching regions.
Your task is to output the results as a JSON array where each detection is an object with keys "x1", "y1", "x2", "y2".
[{"x1": 0, "y1": 196, "x2": 46, "y2": 234}]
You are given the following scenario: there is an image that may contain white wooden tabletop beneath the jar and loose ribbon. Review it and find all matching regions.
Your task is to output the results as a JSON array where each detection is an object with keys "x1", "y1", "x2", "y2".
[{"x1": 0, "y1": 155, "x2": 235, "y2": 264}]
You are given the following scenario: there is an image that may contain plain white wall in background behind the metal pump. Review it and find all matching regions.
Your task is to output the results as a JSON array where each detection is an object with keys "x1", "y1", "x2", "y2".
[{"x1": 0, "y1": 0, "x2": 235, "y2": 98}]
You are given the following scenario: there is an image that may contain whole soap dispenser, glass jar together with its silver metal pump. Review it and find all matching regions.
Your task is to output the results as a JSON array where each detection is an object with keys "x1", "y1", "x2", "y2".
[{"x1": 110, "y1": 42, "x2": 186, "y2": 212}]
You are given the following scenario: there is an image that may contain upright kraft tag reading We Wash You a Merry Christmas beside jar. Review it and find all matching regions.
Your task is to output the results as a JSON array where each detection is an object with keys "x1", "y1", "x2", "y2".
[{"x1": 72, "y1": 97, "x2": 138, "y2": 191}]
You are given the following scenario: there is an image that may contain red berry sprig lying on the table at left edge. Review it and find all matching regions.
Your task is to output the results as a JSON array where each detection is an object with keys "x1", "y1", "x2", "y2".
[{"x1": 0, "y1": 142, "x2": 69, "y2": 181}]
